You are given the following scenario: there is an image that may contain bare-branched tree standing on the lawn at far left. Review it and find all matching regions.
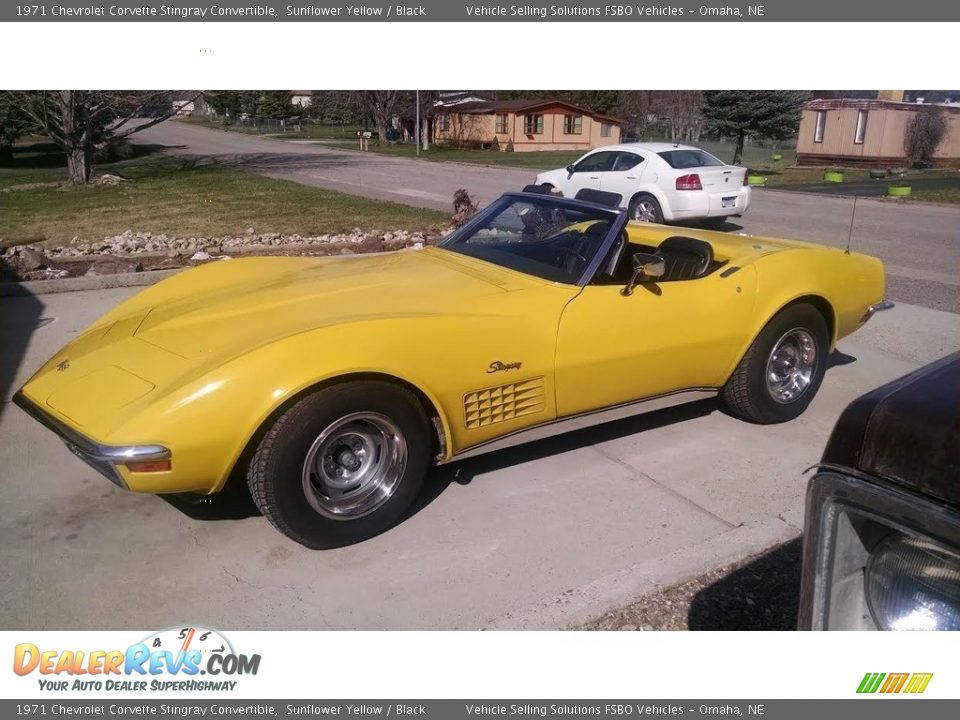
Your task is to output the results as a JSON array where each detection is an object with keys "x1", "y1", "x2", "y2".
[{"x1": 3, "y1": 90, "x2": 200, "y2": 185}]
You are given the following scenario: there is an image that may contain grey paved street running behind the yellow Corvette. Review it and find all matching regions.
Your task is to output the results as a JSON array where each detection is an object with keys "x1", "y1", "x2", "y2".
[{"x1": 132, "y1": 122, "x2": 960, "y2": 312}]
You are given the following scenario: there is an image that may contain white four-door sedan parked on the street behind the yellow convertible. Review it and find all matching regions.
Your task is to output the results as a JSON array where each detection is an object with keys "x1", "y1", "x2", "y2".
[{"x1": 537, "y1": 143, "x2": 750, "y2": 224}]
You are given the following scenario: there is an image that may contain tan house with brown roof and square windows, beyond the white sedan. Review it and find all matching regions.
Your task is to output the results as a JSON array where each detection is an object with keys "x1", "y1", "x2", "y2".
[{"x1": 434, "y1": 100, "x2": 624, "y2": 152}]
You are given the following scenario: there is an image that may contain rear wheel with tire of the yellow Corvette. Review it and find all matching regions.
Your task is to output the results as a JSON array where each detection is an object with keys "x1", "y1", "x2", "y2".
[{"x1": 720, "y1": 303, "x2": 830, "y2": 425}]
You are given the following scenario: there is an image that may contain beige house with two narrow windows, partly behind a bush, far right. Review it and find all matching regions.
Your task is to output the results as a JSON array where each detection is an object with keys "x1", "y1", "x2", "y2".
[{"x1": 797, "y1": 99, "x2": 960, "y2": 167}]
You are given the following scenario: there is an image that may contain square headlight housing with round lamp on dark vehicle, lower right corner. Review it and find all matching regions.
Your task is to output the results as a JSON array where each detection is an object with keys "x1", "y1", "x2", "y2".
[{"x1": 799, "y1": 469, "x2": 960, "y2": 630}]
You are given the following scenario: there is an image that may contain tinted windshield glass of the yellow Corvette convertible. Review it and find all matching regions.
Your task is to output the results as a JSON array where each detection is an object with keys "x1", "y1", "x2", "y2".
[{"x1": 440, "y1": 197, "x2": 615, "y2": 285}]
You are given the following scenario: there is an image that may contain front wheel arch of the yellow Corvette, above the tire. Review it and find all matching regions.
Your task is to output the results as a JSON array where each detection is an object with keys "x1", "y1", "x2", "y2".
[{"x1": 218, "y1": 371, "x2": 451, "y2": 492}]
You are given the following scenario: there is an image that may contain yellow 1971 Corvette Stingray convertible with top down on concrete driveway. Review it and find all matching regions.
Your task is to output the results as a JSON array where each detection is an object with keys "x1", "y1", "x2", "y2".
[{"x1": 15, "y1": 193, "x2": 886, "y2": 548}]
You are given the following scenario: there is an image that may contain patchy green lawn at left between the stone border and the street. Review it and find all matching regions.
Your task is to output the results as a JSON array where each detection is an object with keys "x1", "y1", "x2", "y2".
[{"x1": 0, "y1": 143, "x2": 452, "y2": 244}]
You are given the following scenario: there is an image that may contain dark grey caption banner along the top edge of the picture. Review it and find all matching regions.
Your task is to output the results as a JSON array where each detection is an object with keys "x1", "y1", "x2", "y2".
[{"x1": 7, "y1": 0, "x2": 960, "y2": 23}]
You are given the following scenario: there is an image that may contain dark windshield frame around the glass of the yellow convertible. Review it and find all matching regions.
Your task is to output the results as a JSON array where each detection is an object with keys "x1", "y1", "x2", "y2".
[{"x1": 437, "y1": 192, "x2": 628, "y2": 287}]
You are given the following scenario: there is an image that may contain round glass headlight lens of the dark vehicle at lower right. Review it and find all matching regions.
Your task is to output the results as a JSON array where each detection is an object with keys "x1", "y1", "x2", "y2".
[{"x1": 865, "y1": 533, "x2": 960, "y2": 630}]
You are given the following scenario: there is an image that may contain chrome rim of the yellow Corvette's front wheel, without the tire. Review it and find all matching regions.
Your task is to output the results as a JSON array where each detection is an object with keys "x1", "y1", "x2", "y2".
[{"x1": 303, "y1": 413, "x2": 407, "y2": 520}]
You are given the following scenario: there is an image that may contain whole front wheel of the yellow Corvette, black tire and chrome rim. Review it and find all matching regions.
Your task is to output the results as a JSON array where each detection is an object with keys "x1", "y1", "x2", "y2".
[{"x1": 247, "y1": 381, "x2": 432, "y2": 549}]
